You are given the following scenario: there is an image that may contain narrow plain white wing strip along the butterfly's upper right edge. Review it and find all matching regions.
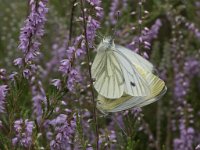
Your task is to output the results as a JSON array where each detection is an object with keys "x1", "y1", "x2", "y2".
[{"x1": 116, "y1": 45, "x2": 154, "y2": 72}]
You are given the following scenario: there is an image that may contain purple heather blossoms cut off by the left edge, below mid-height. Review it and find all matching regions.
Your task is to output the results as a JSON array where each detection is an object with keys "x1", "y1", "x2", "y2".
[{"x1": 0, "y1": 85, "x2": 8, "y2": 113}]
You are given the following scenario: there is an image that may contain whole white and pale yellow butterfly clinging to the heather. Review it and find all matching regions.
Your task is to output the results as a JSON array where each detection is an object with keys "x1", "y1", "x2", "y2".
[{"x1": 91, "y1": 37, "x2": 167, "y2": 113}]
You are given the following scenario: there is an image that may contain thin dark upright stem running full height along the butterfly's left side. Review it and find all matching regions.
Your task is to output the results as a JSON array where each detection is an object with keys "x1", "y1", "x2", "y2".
[{"x1": 80, "y1": 0, "x2": 99, "y2": 150}]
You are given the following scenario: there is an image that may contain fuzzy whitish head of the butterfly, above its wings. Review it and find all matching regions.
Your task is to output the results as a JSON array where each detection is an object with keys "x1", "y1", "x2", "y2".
[{"x1": 97, "y1": 37, "x2": 115, "y2": 51}]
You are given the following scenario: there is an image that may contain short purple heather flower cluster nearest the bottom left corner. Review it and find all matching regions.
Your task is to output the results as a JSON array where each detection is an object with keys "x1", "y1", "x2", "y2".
[{"x1": 12, "y1": 119, "x2": 34, "y2": 148}]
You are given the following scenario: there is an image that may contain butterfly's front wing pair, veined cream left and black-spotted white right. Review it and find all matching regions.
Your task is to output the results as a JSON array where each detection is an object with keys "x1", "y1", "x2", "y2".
[{"x1": 91, "y1": 47, "x2": 150, "y2": 99}]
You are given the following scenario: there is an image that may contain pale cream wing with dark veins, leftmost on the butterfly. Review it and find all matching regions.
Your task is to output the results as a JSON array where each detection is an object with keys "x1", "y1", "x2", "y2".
[{"x1": 91, "y1": 50, "x2": 124, "y2": 99}]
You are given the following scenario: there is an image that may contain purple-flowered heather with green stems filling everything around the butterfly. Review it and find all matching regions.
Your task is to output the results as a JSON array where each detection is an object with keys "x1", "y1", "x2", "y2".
[{"x1": 0, "y1": 0, "x2": 200, "y2": 150}]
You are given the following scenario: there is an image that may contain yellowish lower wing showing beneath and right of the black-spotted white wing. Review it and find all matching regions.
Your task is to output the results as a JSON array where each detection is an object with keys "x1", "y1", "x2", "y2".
[{"x1": 97, "y1": 69, "x2": 167, "y2": 113}]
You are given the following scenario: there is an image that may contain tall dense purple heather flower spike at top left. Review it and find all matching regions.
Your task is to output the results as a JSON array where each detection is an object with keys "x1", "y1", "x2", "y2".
[{"x1": 18, "y1": 0, "x2": 48, "y2": 63}]
